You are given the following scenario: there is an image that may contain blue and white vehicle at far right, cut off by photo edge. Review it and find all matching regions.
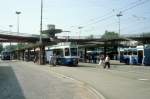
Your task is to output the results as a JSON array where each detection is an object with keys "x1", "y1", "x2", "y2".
[{"x1": 120, "y1": 46, "x2": 150, "y2": 65}]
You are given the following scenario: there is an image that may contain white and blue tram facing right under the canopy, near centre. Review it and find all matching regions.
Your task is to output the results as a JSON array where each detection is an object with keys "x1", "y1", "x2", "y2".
[{"x1": 46, "y1": 42, "x2": 79, "y2": 66}]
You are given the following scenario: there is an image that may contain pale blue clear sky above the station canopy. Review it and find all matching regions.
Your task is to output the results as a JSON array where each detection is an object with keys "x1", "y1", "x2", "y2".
[{"x1": 0, "y1": 0, "x2": 150, "y2": 36}]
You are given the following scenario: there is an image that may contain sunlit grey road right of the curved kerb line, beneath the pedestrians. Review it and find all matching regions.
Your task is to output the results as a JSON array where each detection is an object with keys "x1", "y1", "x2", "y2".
[{"x1": 51, "y1": 64, "x2": 150, "y2": 99}]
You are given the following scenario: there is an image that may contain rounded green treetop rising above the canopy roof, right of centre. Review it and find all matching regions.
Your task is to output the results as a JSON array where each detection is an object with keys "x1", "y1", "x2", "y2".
[{"x1": 101, "y1": 31, "x2": 119, "y2": 40}]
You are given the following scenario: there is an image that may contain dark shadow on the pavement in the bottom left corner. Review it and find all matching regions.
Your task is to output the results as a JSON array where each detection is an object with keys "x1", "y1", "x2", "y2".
[{"x1": 0, "y1": 66, "x2": 25, "y2": 99}]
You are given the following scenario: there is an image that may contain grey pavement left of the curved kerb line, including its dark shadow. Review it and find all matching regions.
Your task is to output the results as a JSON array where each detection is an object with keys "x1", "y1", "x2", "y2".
[{"x1": 0, "y1": 61, "x2": 96, "y2": 99}]
